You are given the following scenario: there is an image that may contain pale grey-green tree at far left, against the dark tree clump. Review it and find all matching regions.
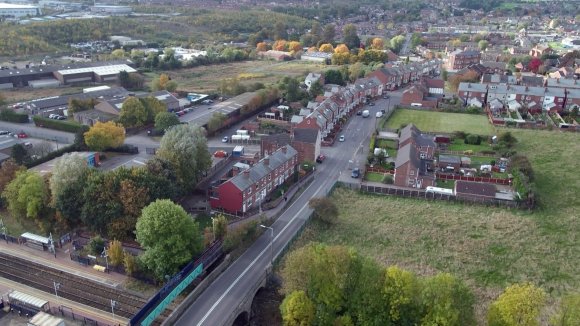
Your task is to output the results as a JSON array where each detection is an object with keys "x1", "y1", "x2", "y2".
[{"x1": 50, "y1": 153, "x2": 89, "y2": 204}]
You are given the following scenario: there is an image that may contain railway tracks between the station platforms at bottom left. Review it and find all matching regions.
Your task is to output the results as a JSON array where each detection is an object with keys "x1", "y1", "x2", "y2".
[{"x1": 0, "y1": 253, "x2": 152, "y2": 318}]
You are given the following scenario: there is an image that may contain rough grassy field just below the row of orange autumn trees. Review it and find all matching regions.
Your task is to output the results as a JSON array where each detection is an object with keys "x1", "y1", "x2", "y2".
[{"x1": 145, "y1": 60, "x2": 333, "y2": 93}]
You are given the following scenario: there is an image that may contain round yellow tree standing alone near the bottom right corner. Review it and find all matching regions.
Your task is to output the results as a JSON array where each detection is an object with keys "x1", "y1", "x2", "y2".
[{"x1": 487, "y1": 283, "x2": 546, "y2": 326}]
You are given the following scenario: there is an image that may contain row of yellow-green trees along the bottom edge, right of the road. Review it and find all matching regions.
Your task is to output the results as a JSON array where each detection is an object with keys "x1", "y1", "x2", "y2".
[{"x1": 280, "y1": 243, "x2": 580, "y2": 326}]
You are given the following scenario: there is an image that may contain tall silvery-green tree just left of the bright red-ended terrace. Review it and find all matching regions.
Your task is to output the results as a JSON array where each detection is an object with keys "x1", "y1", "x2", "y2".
[{"x1": 157, "y1": 124, "x2": 211, "y2": 190}]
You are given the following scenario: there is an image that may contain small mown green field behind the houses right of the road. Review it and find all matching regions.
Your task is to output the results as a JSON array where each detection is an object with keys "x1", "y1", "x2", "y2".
[{"x1": 387, "y1": 109, "x2": 494, "y2": 135}]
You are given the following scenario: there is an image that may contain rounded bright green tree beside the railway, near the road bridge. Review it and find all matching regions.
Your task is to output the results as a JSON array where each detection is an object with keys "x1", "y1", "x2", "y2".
[{"x1": 136, "y1": 199, "x2": 203, "y2": 280}]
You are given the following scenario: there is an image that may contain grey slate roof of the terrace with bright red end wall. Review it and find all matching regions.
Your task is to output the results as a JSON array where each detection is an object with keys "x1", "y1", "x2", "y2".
[{"x1": 230, "y1": 145, "x2": 298, "y2": 191}]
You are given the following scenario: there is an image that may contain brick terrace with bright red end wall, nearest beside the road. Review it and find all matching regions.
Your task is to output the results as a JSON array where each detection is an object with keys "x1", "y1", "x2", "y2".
[{"x1": 209, "y1": 145, "x2": 298, "y2": 214}]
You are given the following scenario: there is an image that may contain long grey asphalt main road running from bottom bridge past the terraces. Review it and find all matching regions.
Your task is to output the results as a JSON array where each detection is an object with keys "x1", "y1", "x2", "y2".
[{"x1": 176, "y1": 91, "x2": 401, "y2": 326}]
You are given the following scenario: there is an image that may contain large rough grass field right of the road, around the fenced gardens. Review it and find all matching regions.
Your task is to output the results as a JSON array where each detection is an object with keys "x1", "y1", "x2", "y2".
[{"x1": 297, "y1": 130, "x2": 580, "y2": 324}]
